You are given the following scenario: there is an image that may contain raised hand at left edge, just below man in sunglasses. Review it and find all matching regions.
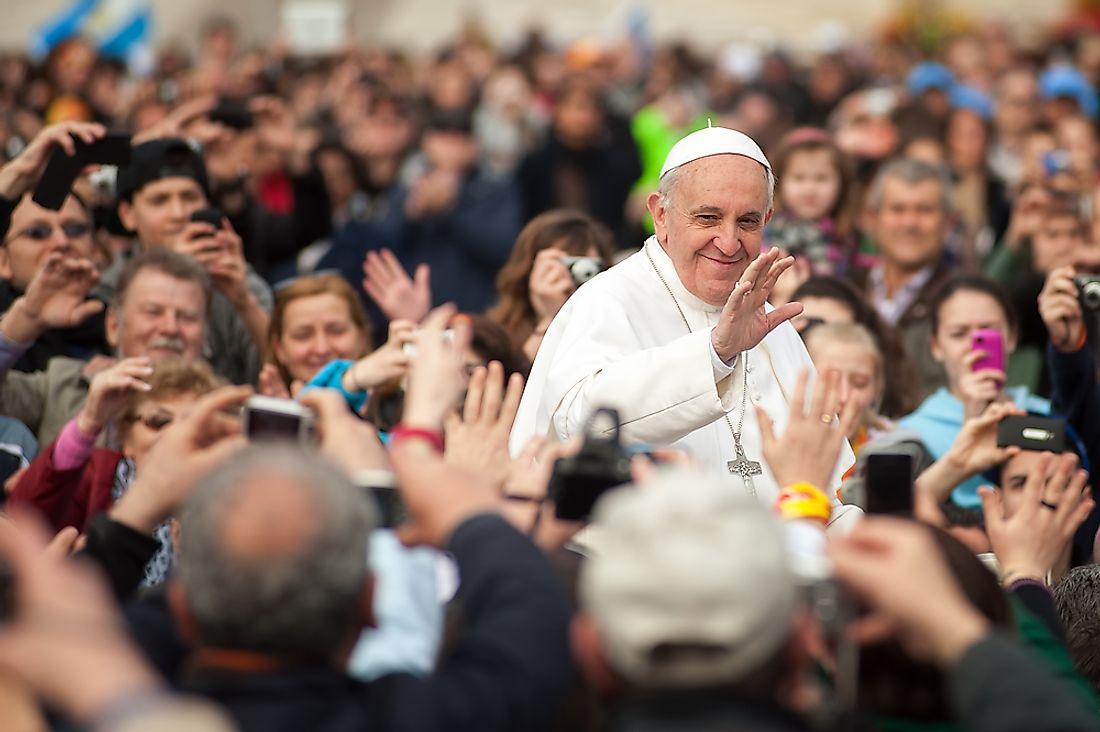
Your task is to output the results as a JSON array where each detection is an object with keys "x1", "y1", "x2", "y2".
[{"x1": 0, "y1": 252, "x2": 103, "y2": 343}]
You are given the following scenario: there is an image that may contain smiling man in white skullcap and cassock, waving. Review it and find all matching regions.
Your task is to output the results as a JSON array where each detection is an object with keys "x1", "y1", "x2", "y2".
[{"x1": 512, "y1": 128, "x2": 858, "y2": 522}]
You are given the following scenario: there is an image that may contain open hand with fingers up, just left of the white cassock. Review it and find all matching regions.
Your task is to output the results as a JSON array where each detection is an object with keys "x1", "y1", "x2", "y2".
[{"x1": 443, "y1": 361, "x2": 524, "y2": 489}]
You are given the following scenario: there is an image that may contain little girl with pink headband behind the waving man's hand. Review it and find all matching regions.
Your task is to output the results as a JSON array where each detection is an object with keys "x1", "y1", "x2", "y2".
[{"x1": 765, "y1": 128, "x2": 856, "y2": 278}]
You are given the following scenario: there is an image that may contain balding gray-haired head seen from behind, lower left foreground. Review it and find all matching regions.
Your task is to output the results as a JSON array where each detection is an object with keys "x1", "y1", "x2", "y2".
[{"x1": 178, "y1": 446, "x2": 378, "y2": 664}]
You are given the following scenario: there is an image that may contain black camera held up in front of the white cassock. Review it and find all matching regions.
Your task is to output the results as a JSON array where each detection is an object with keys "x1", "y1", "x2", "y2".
[{"x1": 549, "y1": 407, "x2": 630, "y2": 521}]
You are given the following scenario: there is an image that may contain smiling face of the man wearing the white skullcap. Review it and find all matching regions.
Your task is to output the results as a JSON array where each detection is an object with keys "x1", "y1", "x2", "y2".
[{"x1": 649, "y1": 155, "x2": 771, "y2": 306}]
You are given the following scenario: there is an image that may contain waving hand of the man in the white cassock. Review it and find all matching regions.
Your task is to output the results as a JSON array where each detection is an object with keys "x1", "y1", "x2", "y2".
[{"x1": 711, "y1": 249, "x2": 802, "y2": 361}]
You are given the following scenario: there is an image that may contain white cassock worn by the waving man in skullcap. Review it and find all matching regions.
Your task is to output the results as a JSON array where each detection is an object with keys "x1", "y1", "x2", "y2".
[{"x1": 510, "y1": 237, "x2": 861, "y2": 528}]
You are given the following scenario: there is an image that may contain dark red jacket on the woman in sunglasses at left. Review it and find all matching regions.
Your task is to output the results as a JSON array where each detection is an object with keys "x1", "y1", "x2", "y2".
[{"x1": 9, "y1": 441, "x2": 122, "y2": 533}]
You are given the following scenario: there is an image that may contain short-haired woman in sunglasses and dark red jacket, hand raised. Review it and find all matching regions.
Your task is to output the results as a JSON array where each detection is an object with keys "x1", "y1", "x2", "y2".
[{"x1": 10, "y1": 358, "x2": 222, "y2": 584}]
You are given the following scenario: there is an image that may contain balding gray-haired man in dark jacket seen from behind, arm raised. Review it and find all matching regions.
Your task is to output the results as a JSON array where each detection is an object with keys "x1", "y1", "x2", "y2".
[{"x1": 154, "y1": 442, "x2": 573, "y2": 732}]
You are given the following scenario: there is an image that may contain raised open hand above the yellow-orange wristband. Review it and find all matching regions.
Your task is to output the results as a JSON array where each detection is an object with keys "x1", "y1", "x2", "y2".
[{"x1": 756, "y1": 369, "x2": 862, "y2": 494}]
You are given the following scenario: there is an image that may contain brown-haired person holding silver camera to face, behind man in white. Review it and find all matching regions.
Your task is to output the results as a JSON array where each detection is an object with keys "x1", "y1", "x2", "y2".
[{"x1": 487, "y1": 210, "x2": 614, "y2": 360}]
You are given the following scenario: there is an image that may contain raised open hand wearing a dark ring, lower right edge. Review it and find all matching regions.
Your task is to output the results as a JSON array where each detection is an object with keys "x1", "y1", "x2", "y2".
[{"x1": 979, "y1": 454, "x2": 1095, "y2": 582}]
